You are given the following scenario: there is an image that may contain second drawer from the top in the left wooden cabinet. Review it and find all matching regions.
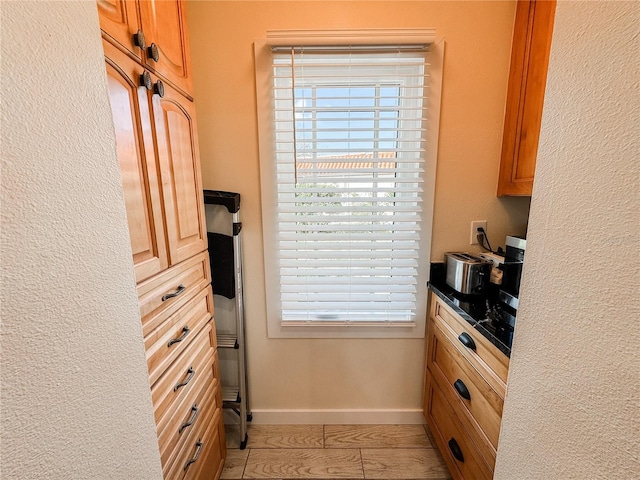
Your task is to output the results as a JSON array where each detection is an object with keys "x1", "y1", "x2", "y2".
[{"x1": 144, "y1": 287, "x2": 213, "y2": 385}]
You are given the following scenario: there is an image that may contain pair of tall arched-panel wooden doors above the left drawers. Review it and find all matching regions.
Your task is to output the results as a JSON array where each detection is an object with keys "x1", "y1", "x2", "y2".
[{"x1": 103, "y1": 41, "x2": 207, "y2": 282}]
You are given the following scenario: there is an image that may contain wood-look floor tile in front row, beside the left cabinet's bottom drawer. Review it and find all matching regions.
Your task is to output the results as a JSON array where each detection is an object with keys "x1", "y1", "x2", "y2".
[{"x1": 243, "y1": 449, "x2": 364, "y2": 479}]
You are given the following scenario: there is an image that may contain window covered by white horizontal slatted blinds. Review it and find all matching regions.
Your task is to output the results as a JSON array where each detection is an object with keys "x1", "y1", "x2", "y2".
[{"x1": 252, "y1": 31, "x2": 437, "y2": 337}]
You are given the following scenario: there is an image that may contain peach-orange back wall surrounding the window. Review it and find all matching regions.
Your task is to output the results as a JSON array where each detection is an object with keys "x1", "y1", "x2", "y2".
[{"x1": 188, "y1": 1, "x2": 529, "y2": 421}]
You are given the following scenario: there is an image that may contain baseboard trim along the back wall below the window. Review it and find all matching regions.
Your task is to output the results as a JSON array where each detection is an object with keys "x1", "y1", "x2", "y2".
[{"x1": 245, "y1": 409, "x2": 425, "y2": 425}]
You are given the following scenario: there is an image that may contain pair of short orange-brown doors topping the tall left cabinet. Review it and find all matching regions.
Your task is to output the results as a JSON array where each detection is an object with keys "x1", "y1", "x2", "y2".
[{"x1": 98, "y1": 0, "x2": 193, "y2": 99}]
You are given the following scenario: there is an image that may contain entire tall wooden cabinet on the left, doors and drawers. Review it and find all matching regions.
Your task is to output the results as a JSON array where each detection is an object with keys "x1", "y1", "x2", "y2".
[{"x1": 98, "y1": 0, "x2": 226, "y2": 480}]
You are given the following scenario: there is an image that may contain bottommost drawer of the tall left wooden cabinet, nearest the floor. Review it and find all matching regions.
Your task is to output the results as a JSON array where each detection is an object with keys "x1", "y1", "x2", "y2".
[{"x1": 164, "y1": 408, "x2": 223, "y2": 480}]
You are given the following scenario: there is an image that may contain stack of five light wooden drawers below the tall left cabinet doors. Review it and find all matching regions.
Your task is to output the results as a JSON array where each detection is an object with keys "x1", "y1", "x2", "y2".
[{"x1": 138, "y1": 258, "x2": 226, "y2": 480}]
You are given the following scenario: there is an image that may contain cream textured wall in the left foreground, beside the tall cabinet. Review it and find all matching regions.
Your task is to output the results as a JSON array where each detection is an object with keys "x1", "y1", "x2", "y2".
[{"x1": 0, "y1": 1, "x2": 162, "y2": 480}]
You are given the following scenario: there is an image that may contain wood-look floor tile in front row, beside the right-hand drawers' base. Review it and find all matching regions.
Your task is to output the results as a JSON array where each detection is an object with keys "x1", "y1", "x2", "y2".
[{"x1": 361, "y1": 448, "x2": 449, "y2": 480}]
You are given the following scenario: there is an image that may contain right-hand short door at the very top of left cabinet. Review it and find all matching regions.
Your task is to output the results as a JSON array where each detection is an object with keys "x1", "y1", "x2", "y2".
[{"x1": 140, "y1": 0, "x2": 192, "y2": 97}]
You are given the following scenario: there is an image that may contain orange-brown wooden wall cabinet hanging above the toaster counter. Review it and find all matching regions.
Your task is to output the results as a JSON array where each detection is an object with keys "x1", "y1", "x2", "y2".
[{"x1": 498, "y1": 0, "x2": 556, "y2": 196}]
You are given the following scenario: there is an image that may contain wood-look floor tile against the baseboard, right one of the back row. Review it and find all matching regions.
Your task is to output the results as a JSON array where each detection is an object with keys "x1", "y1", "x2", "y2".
[{"x1": 324, "y1": 425, "x2": 431, "y2": 448}]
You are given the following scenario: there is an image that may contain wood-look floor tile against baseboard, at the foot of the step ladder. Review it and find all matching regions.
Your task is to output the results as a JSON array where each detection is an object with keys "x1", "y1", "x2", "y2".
[{"x1": 247, "y1": 425, "x2": 323, "y2": 448}]
